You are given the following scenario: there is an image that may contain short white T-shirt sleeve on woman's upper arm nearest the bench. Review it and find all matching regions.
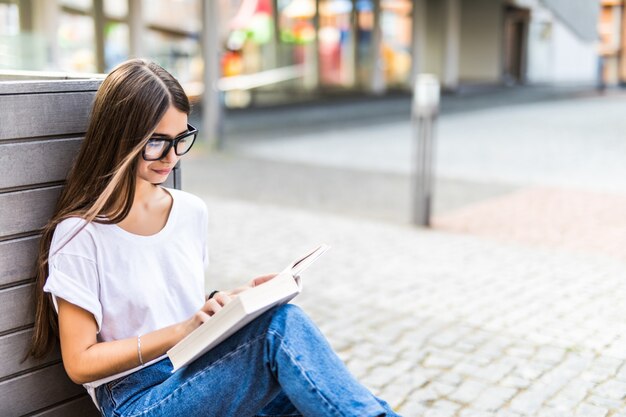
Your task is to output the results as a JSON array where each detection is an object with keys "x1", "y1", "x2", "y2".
[{"x1": 43, "y1": 253, "x2": 102, "y2": 333}]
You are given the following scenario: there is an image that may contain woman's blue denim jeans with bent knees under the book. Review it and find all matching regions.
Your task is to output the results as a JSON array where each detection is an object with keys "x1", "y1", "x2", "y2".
[{"x1": 96, "y1": 304, "x2": 397, "y2": 417}]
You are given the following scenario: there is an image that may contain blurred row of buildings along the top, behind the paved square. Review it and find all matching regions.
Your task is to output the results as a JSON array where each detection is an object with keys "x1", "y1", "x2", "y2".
[{"x1": 0, "y1": 0, "x2": 600, "y2": 107}]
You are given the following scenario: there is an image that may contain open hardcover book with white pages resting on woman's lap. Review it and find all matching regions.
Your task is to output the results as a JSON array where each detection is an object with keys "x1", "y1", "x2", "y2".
[{"x1": 167, "y1": 245, "x2": 329, "y2": 372}]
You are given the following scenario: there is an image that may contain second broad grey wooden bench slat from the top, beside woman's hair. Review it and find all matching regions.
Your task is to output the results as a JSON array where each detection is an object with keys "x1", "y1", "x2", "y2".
[{"x1": 0, "y1": 138, "x2": 82, "y2": 188}]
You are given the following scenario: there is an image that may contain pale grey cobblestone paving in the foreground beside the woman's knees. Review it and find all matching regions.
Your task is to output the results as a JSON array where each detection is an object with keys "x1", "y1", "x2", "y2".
[{"x1": 185, "y1": 192, "x2": 626, "y2": 417}]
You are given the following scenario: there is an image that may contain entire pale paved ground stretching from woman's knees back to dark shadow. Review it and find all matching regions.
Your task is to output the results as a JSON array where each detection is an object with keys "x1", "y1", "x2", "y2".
[{"x1": 183, "y1": 86, "x2": 626, "y2": 417}]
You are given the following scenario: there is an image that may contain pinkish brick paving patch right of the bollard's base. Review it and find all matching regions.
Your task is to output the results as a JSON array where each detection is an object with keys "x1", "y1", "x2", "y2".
[{"x1": 434, "y1": 186, "x2": 626, "y2": 260}]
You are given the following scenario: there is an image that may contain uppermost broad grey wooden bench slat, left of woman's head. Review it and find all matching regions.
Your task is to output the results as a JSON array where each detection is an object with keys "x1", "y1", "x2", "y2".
[{"x1": 0, "y1": 92, "x2": 94, "y2": 140}]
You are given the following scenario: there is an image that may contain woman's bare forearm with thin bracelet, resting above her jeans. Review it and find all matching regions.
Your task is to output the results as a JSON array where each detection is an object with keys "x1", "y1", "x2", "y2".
[{"x1": 63, "y1": 322, "x2": 191, "y2": 384}]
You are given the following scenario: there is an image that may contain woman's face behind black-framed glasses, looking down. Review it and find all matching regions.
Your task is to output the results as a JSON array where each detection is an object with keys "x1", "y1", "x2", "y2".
[{"x1": 137, "y1": 106, "x2": 187, "y2": 184}]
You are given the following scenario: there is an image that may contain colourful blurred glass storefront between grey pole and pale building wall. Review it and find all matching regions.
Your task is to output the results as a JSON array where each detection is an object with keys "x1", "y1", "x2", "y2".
[{"x1": 222, "y1": 0, "x2": 413, "y2": 104}]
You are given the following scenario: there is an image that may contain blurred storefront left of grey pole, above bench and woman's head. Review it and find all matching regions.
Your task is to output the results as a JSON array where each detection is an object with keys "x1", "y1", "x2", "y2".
[{"x1": 0, "y1": 0, "x2": 202, "y2": 82}]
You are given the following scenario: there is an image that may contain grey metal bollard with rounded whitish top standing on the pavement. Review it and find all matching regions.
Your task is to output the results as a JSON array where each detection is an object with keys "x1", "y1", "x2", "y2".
[{"x1": 412, "y1": 74, "x2": 440, "y2": 226}]
